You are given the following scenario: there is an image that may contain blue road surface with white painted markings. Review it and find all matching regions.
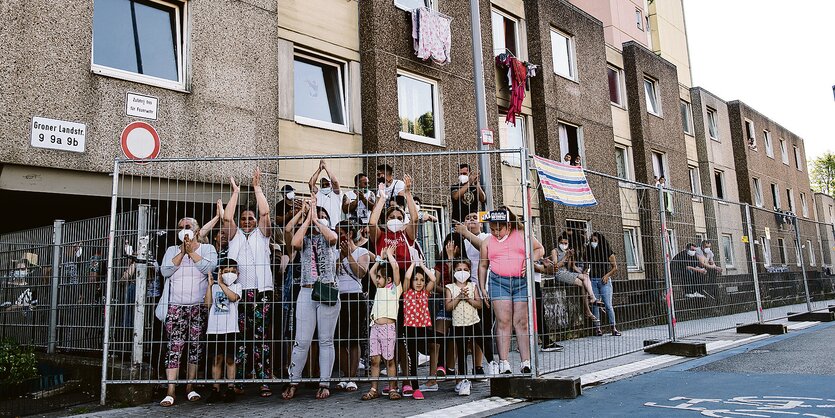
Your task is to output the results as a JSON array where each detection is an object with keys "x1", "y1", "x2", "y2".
[{"x1": 501, "y1": 323, "x2": 835, "y2": 418}]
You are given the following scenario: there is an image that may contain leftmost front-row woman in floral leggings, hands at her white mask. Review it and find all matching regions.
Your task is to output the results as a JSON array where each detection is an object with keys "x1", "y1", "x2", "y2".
[{"x1": 160, "y1": 218, "x2": 217, "y2": 407}]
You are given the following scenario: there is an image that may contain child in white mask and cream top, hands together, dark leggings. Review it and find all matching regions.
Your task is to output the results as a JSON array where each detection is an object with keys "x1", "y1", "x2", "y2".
[{"x1": 444, "y1": 259, "x2": 481, "y2": 396}]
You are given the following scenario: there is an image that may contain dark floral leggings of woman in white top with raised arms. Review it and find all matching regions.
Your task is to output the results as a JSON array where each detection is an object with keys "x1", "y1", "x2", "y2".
[{"x1": 235, "y1": 289, "x2": 273, "y2": 379}]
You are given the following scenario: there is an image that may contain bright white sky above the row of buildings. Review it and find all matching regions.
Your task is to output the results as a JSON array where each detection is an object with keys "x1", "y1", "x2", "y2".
[{"x1": 684, "y1": 0, "x2": 835, "y2": 166}]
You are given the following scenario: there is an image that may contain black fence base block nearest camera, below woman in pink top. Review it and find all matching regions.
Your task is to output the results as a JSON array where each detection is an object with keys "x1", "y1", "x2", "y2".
[{"x1": 490, "y1": 377, "x2": 582, "y2": 399}]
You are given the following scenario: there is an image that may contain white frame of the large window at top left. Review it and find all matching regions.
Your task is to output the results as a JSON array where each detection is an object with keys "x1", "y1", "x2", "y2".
[{"x1": 90, "y1": 0, "x2": 191, "y2": 93}]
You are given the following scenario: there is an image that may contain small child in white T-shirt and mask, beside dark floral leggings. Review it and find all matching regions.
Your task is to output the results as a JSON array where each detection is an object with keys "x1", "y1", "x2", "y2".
[{"x1": 205, "y1": 258, "x2": 241, "y2": 403}]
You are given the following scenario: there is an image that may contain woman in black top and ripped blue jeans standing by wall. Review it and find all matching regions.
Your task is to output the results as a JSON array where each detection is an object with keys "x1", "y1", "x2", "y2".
[{"x1": 586, "y1": 232, "x2": 621, "y2": 337}]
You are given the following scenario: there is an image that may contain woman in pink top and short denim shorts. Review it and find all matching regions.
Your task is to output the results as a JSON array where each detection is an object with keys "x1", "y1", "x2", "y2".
[{"x1": 478, "y1": 207, "x2": 545, "y2": 374}]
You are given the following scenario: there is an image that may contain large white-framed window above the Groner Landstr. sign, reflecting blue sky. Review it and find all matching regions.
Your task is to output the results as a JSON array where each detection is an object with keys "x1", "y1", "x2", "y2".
[{"x1": 92, "y1": 0, "x2": 188, "y2": 90}]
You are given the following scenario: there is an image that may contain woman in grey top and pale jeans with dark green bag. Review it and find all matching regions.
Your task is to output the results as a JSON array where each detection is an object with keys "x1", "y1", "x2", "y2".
[{"x1": 281, "y1": 194, "x2": 340, "y2": 399}]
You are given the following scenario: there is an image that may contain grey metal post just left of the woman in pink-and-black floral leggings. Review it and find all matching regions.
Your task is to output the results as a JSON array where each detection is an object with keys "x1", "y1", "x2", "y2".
[{"x1": 131, "y1": 204, "x2": 150, "y2": 366}]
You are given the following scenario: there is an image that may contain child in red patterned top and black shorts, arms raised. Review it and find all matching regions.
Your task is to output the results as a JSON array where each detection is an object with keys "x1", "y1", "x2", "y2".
[{"x1": 403, "y1": 261, "x2": 445, "y2": 400}]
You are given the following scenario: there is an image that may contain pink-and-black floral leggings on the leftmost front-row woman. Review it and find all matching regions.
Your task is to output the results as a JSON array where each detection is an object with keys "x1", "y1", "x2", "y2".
[{"x1": 165, "y1": 305, "x2": 208, "y2": 369}]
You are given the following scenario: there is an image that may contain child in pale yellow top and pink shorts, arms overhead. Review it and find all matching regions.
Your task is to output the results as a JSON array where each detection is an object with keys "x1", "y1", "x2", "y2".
[{"x1": 362, "y1": 245, "x2": 403, "y2": 401}]
